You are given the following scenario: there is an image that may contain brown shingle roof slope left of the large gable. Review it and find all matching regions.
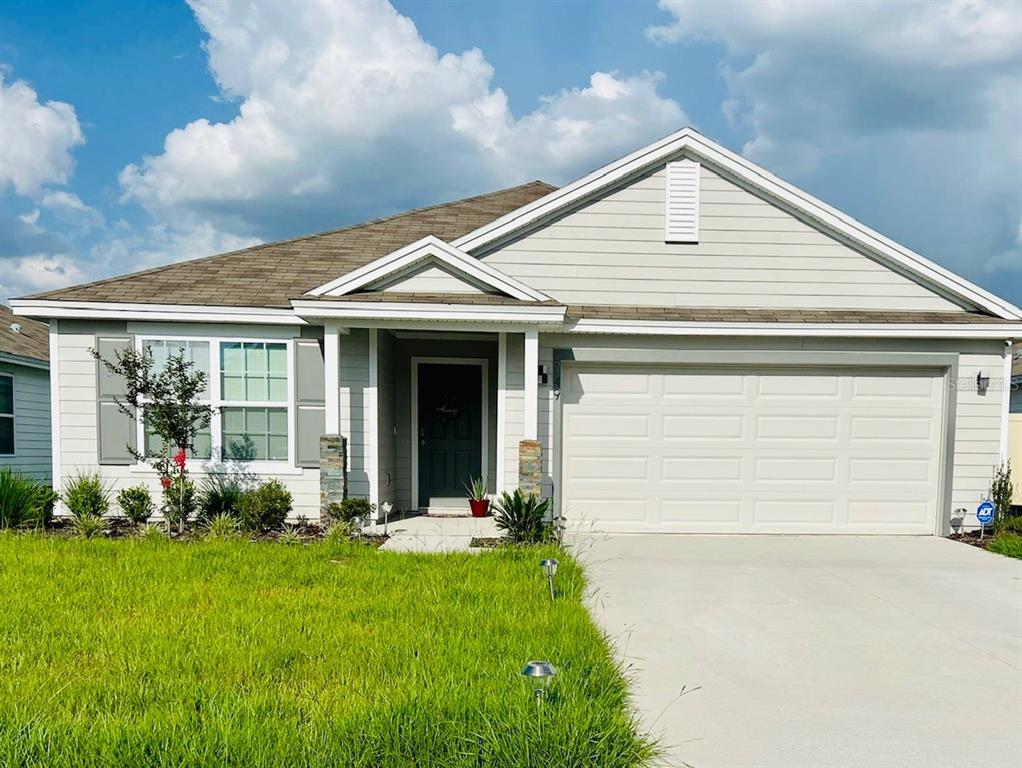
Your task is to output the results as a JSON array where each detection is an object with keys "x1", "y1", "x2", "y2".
[{"x1": 29, "y1": 181, "x2": 555, "y2": 308}]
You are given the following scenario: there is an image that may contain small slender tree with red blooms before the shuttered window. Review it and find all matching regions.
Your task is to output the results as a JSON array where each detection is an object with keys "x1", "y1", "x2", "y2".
[{"x1": 90, "y1": 348, "x2": 214, "y2": 533}]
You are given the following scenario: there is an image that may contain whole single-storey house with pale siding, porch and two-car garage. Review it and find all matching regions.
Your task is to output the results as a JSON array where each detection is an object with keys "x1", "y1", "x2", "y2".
[{"x1": 14, "y1": 129, "x2": 1022, "y2": 534}]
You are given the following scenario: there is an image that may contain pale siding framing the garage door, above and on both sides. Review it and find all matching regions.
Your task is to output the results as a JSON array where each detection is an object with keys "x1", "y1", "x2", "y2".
[{"x1": 539, "y1": 334, "x2": 1008, "y2": 527}]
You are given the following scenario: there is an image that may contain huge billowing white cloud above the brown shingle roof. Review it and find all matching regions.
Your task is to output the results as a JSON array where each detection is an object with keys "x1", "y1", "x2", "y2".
[{"x1": 121, "y1": 0, "x2": 686, "y2": 239}]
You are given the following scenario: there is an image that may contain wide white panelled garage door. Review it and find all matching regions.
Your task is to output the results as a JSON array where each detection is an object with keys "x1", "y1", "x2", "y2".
[{"x1": 560, "y1": 366, "x2": 943, "y2": 534}]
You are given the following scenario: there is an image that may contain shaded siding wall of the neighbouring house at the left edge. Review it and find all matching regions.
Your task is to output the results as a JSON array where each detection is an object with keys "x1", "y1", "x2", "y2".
[{"x1": 0, "y1": 363, "x2": 53, "y2": 482}]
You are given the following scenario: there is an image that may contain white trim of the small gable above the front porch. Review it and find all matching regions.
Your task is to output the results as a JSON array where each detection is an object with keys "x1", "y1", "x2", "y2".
[{"x1": 306, "y1": 235, "x2": 551, "y2": 302}]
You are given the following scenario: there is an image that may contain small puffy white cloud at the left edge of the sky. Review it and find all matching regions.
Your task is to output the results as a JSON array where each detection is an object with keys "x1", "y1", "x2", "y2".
[{"x1": 0, "y1": 69, "x2": 85, "y2": 196}]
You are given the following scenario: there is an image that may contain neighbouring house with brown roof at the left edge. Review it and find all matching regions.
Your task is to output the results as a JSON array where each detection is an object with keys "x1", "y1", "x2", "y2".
[{"x1": 0, "y1": 305, "x2": 52, "y2": 482}]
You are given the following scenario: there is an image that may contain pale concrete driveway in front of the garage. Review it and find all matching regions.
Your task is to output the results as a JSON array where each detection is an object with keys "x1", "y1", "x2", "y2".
[{"x1": 575, "y1": 535, "x2": 1022, "y2": 768}]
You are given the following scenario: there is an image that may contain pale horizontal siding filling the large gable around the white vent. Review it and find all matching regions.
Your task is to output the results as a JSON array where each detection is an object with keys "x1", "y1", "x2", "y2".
[{"x1": 483, "y1": 167, "x2": 958, "y2": 310}]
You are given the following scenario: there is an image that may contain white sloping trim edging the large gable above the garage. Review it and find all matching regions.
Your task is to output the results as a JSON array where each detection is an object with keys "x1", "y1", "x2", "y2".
[{"x1": 452, "y1": 128, "x2": 1022, "y2": 320}]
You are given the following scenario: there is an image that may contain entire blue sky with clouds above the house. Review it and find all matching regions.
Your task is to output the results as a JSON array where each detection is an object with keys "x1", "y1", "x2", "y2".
[{"x1": 0, "y1": 0, "x2": 1022, "y2": 304}]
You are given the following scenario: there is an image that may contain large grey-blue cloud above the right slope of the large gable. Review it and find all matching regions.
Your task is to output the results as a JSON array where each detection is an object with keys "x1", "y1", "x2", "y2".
[{"x1": 647, "y1": 0, "x2": 1022, "y2": 302}]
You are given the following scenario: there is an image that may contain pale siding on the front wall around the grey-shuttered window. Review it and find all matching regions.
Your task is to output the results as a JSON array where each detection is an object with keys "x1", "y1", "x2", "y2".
[{"x1": 55, "y1": 322, "x2": 319, "y2": 519}]
